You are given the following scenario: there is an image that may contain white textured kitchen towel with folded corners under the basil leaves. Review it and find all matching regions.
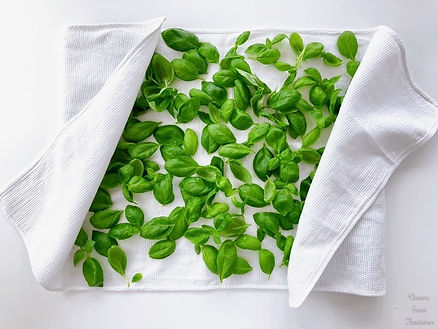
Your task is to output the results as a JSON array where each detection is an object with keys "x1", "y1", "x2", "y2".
[{"x1": 0, "y1": 18, "x2": 438, "y2": 307}]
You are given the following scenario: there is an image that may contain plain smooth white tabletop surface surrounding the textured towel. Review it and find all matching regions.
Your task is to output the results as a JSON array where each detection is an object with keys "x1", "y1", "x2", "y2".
[{"x1": 0, "y1": 0, "x2": 438, "y2": 329}]
